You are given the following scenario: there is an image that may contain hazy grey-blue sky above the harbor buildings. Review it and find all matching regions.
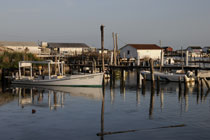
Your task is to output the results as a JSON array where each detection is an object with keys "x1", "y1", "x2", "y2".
[{"x1": 0, "y1": 0, "x2": 210, "y2": 49}]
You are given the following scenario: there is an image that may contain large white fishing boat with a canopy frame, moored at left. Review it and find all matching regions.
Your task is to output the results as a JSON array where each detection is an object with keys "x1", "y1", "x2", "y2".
[{"x1": 12, "y1": 60, "x2": 104, "y2": 87}]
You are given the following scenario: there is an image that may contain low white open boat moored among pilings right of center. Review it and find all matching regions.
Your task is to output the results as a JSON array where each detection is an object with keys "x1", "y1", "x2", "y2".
[{"x1": 141, "y1": 71, "x2": 195, "y2": 82}]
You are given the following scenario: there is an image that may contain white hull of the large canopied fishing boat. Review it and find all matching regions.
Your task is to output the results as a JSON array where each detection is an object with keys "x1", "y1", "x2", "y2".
[{"x1": 12, "y1": 73, "x2": 103, "y2": 87}]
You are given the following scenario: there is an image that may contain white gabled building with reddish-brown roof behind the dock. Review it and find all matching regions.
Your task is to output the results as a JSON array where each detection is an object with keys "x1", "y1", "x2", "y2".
[{"x1": 120, "y1": 44, "x2": 162, "y2": 59}]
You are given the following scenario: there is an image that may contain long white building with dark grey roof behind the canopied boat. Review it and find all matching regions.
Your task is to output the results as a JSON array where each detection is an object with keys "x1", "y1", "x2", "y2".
[{"x1": 47, "y1": 42, "x2": 90, "y2": 55}]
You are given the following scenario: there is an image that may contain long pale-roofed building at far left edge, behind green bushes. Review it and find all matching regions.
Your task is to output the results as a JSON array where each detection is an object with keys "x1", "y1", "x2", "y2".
[{"x1": 0, "y1": 41, "x2": 41, "y2": 54}]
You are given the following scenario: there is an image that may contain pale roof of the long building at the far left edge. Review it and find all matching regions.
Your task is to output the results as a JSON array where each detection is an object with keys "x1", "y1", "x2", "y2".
[{"x1": 0, "y1": 41, "x2": 38, "y2": 47}]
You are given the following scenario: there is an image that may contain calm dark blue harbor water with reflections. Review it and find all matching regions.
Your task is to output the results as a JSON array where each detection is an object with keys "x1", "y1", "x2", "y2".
[{"x1": 0, "y1": 72, "x2": 210, "y2": 140}]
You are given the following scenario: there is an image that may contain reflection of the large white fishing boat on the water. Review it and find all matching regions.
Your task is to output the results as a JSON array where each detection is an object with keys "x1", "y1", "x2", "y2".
[{"x1": 10, "y1": 85, "x2": 103, "y2": 110}]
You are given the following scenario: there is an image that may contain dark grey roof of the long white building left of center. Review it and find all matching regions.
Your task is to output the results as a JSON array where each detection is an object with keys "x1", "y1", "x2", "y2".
[{"x1": 47, "y1": 43, "x2": 90, "y2": 48}]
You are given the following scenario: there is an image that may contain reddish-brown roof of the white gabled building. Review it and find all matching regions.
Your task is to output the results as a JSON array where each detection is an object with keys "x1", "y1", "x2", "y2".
[{"x1": 123, "y1": 44, "x2": 162, "y2": 50}]
